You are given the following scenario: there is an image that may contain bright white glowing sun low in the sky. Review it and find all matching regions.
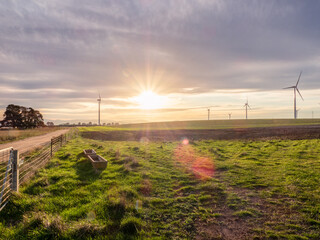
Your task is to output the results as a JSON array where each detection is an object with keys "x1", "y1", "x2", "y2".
[{"x1": 134, "y1": 91, "x2": 166, "y2": 109}]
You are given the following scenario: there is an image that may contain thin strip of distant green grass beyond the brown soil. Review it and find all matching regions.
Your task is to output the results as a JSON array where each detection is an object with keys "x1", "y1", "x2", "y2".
[{"x1": 80, "y1": 119, "x2": 320, "y2": 131}]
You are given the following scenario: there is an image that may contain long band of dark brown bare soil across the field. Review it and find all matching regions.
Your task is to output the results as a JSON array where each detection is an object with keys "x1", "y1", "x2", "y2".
[{"x1": 82, "y1": 125, "x2": 320, "y2": 141}]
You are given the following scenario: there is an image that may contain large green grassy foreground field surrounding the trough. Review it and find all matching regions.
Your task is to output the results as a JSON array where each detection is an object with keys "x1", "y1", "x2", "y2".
[{"x1": 0, "y1": 135, "x2": 320, "y2": 239}]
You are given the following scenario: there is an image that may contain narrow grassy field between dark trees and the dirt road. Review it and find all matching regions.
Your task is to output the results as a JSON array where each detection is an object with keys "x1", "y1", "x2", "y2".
[{"x1": 0, "y1": 127, "x2": 61, "y2": 144}]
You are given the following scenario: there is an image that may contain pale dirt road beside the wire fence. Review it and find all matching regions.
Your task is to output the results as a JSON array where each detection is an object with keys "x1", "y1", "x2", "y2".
[{"x1": 0, "y1": 129, "x2": 69, "y2": 155}]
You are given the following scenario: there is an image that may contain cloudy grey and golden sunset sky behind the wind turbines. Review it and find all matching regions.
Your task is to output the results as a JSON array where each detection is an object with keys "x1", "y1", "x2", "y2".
[{"x1": 0, "y1": 0, "x2": 320, "y2": 123}]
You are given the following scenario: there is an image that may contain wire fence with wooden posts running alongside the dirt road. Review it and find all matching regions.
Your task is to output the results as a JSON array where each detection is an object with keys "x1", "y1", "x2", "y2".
[{"x1": 0, "y1": 129, "x2": 78, "y2": 211}]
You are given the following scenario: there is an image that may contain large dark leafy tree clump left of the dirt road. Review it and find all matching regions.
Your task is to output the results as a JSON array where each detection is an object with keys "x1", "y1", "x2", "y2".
[{"x1": 1, "y1": 104, "x2": 44, "y2": 129}]
